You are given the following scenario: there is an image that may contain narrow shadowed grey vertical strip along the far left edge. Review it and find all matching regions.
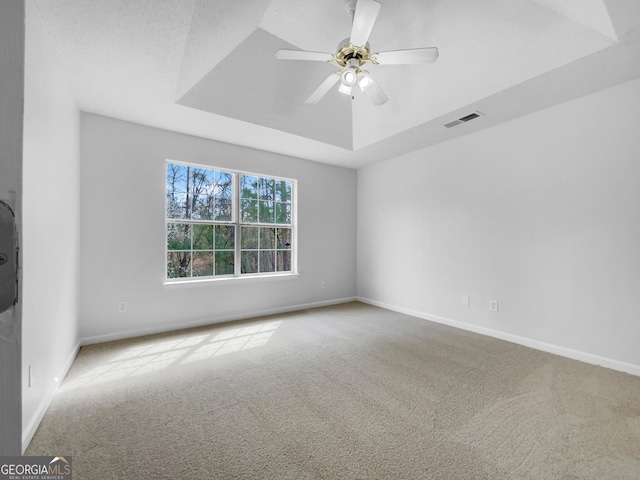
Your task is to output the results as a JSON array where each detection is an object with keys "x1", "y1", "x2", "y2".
[{"x1": 0, "y1": 2, "x2": 25, "y2": 456}]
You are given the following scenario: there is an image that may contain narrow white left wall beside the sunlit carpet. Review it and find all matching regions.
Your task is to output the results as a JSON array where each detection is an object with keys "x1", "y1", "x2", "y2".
[{"x1": 22, "y1": 1, "x2": 80, "y2": 447}]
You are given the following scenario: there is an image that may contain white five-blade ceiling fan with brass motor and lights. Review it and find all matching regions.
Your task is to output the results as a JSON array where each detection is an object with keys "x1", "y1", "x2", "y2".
[{"x1": 276, "y1": 0, "x2": 438, "y2": 106}]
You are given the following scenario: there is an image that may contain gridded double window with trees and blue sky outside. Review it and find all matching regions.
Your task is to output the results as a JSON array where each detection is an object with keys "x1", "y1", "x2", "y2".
[{"x1": 166, "y1": 163, "x2": 295, "y2": 279}]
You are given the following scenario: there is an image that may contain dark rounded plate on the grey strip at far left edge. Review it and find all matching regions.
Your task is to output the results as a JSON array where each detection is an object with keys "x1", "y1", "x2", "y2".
[{"x1": 0, "y1": 202, "x2": 18, "y2": 313}]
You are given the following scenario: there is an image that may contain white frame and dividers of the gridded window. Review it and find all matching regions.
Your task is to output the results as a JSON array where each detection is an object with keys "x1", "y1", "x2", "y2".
[{"x1": 163, "y1": 159, "x2": 298, "y2": 284}]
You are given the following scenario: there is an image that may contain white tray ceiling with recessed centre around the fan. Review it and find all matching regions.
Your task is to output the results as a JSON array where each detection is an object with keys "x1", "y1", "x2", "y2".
[{"x1": 34, "y1": 0, "x2": 640, "y2": 168}]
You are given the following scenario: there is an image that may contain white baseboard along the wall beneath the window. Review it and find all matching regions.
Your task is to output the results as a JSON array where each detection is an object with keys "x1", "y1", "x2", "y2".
[{"x1": 80, "y1": 297, "x2": 356, "y2": 346}]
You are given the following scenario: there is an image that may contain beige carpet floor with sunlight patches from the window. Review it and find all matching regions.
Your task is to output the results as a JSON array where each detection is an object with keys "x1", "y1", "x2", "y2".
[{"x1": 26, "y1": 303, "x2": 640, "y2": 480}]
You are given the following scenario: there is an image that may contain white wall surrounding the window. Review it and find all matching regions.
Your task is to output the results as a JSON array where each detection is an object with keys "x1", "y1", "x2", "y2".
[{"x1": 80, "y1": 114, "x2": 356, "y2": 342}]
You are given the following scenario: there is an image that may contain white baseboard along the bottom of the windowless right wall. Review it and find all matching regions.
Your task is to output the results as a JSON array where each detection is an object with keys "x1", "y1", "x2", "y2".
[{"x1": 357, "y1": 297, "x2": 640, "y2": 376}]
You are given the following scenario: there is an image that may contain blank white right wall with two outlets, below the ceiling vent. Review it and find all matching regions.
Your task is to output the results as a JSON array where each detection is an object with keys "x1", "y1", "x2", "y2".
[{"x1": 358, "y1": 80, "x2": 640, "y2": 374}]
